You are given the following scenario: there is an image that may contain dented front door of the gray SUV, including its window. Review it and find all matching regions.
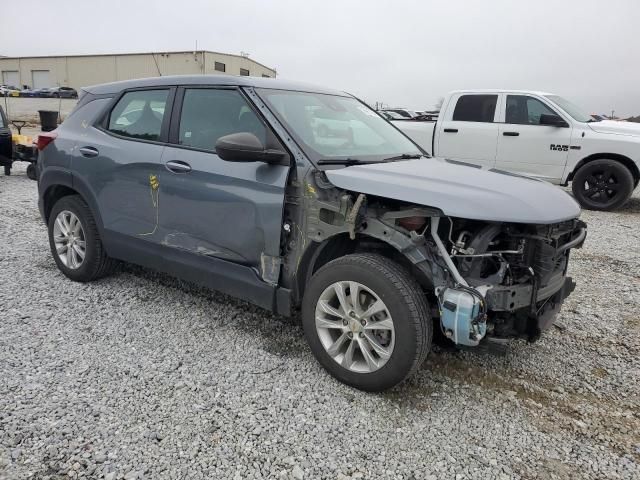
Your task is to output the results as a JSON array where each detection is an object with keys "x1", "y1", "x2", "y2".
[{"x1": 159, "y1": 87, "x2": 289, "y2": 269}]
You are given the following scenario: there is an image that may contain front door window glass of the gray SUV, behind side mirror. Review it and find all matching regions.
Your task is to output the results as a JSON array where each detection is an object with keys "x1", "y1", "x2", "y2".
[{"x1": 178, "y1": 88, "x2": 267, "y2": 151}]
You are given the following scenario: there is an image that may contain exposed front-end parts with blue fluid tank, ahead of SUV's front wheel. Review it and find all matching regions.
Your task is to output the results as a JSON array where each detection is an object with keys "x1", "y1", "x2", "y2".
[{"x1": 438, "y1": 218, "x2": 586, "y2": 346}]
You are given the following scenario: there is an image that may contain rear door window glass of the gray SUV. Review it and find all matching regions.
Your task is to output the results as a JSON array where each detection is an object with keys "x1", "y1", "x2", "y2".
[{"x1": 107, "y1": 89, "x2": 169, "y2": 141}]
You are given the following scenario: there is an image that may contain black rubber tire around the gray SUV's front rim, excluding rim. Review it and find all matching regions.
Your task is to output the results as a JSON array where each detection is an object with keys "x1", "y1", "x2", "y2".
[{"x1": 302, "y1": 253, "x2": 433, "y2": 392}]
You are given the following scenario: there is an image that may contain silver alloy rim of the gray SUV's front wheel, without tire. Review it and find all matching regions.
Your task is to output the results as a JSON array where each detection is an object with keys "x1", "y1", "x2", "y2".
[{"x1": 315, "y1": 281, "x2": 395, "y2": 373}]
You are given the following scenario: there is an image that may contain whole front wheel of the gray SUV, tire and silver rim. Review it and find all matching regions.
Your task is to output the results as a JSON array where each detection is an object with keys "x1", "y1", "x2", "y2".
[{"x1": 302, "y1": 254, "x2": 433, "y2": 392}]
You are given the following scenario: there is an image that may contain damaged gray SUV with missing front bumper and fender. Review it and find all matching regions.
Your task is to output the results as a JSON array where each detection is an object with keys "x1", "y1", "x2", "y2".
[{"x1": 38, "y1": 75, "x2": 586, "y2": 391}]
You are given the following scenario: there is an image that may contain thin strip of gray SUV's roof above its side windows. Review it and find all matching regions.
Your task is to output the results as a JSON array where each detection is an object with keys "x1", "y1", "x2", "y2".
[{"x1": 83, "y1": 75, "x2": 348, "y2": 96}]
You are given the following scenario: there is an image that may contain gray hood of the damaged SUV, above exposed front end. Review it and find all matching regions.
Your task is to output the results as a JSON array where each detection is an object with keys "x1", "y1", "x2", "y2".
[{"x1": 325, "y1": 158, "x2": 580, "y2": 224}]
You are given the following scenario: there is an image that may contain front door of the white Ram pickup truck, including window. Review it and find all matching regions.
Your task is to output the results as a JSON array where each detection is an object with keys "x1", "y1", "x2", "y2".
[{"x1": 496, "y1": 94, "x2": 572, "y2": 183}]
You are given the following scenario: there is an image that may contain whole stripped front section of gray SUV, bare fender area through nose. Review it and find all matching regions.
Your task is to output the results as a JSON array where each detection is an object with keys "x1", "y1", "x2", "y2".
[{"x1": 285, "y1": 174, "x2": 586, "y2": 347}]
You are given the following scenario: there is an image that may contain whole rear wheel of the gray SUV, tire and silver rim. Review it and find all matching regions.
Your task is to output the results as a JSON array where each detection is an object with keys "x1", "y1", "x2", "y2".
[{"x1": 49, "y1": 195, "x2": 116, "y2": 282}]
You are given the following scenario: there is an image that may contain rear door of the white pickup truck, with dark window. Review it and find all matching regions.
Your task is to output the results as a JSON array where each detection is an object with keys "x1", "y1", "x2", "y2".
[{"x1": 435, "y1": 93, "x2": 501, "y2": 167}]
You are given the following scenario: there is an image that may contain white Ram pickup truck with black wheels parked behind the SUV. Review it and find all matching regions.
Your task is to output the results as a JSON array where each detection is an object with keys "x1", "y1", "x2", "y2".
[{"x1": 392, "y1": 90, "x2": 640, "y2": 210}]
